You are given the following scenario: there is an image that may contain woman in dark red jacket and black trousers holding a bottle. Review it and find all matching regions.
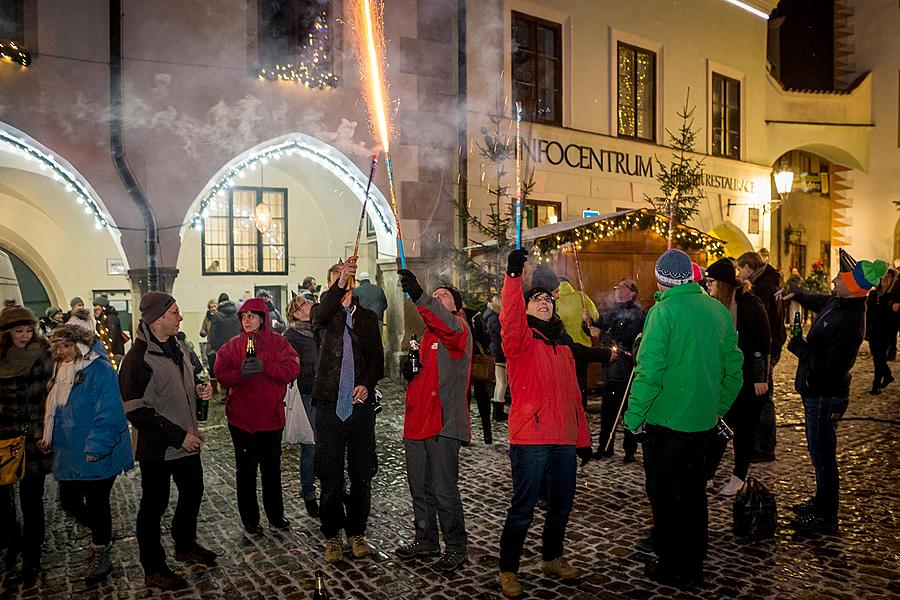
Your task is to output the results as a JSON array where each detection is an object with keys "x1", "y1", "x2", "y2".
[{"x1": 216, "y1": 298, "x2": 300, "y2": 534}]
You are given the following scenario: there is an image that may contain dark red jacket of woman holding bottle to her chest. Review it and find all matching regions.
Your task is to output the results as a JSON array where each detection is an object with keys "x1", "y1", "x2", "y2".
[{"x1": 216, "y1": 298, "x2": 300, "y2": 433}]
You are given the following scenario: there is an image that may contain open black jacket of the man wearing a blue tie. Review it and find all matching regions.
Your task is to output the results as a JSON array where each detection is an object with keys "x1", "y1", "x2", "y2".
[{"x1": 312, "y1": 279, "x2": 384, "y2": 402}]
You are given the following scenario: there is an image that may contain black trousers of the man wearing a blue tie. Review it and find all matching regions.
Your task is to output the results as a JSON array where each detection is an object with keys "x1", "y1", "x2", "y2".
[{"x1": 316, "y1": 401, "x2": 378, "y2": 539}]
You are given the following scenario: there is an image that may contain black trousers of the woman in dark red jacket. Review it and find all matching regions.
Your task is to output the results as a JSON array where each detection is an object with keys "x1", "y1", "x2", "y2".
[{"x1": 228, "y1": 425, "x2": 284, "y2": 527}]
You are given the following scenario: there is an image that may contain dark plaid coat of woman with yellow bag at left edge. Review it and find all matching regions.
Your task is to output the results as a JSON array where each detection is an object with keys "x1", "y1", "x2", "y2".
[{"x1": 0, "y1": 339, "x2": 53, "y2": 477}]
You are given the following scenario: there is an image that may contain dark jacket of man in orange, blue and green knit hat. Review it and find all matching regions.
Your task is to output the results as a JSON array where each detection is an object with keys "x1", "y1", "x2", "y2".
[{"x1": 788, "y1": 292, "x2": 866, "y2": 398}]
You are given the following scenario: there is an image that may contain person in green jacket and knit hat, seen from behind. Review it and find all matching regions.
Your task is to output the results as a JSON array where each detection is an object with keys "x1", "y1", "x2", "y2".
[{"x1": 625, "y1": 249, "x2": 744, "y2": 586}]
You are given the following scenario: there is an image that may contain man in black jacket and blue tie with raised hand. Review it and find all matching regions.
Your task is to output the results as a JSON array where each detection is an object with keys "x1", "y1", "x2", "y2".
[{"x1": 312, "y1": 256, "x2": 384, "y2": 563}]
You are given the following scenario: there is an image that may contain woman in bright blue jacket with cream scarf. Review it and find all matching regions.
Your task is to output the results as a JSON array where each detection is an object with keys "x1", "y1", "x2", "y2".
[{"x1": 40, "y1": 311, "x2": 134, "y2": 583}]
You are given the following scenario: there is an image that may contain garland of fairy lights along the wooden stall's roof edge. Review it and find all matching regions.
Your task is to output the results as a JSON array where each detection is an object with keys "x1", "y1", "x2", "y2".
[{"x1": 531, "y1": 208, "x2": 725, "y2": 263}]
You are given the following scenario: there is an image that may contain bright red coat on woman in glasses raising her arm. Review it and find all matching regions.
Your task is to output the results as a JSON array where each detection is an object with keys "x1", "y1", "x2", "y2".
[{"x1": 500, "y1": 275, "x2": 591, "y2": 448}]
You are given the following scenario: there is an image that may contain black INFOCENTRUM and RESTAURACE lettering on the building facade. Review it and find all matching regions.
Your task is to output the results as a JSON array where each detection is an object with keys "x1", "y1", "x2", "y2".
[{"x1": 523, "y1": 137, "x2": 756, "y2": 194}]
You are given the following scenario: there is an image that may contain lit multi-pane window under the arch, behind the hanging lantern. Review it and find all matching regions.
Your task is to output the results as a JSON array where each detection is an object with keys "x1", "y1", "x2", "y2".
[{"x1": 202, "y1": 187, "x2": 287, "y2": 275}]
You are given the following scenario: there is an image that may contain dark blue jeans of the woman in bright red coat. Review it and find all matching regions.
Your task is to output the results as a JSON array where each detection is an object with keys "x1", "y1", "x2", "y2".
[{"x1": 500, "y1": 445, "x2": 576, "y2": 573}]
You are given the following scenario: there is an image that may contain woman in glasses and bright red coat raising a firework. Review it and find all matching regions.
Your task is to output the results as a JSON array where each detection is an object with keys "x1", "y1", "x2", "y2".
[{"x1": 500, "y1": 250, "x2": 614, "y2": 598}]
